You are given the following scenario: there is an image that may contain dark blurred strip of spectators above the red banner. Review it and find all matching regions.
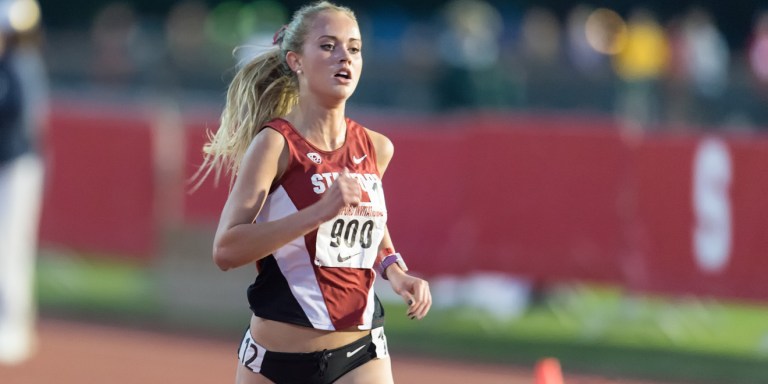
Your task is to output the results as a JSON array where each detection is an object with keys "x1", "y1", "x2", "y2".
[{"x1": 41, "y1": 0, "x2": 768, "y2": 130}]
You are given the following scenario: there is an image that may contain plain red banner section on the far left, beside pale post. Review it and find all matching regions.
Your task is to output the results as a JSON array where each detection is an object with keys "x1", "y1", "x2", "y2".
[{"x1": 40, "y1": 103, "x2": 158, "y2": 258}]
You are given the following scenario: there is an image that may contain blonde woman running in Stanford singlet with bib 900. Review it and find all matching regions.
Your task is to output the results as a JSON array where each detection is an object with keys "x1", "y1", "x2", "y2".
[{"x1": 194, "y1": 2, "x2": 432, "y2": 383}]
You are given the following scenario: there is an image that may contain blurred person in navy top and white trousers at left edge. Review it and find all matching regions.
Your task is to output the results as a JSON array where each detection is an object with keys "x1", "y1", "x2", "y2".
[{"x1": 0, "y1": 0, "x2": 48, "y2": 364}]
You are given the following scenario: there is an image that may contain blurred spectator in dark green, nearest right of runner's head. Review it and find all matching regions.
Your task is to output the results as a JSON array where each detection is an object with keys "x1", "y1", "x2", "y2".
[{"x1": 438, "y1": 0, "x2": 505, "y2": 109}]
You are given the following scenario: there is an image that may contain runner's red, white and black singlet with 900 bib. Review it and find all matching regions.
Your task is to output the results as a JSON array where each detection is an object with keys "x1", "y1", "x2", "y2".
[{"x1": 248, "y1": 119, "x2": 387, "y2": 330}]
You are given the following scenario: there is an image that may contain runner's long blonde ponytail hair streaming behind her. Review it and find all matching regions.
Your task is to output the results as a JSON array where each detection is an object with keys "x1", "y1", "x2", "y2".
[{"x1": 193, "y1": 1, "x2": 357, "y2": 190}]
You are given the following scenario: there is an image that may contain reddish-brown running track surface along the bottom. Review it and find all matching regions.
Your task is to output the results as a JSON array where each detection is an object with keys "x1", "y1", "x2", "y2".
[{"x1": 0, "y1": 320, "x2": 680, "y2": 384}]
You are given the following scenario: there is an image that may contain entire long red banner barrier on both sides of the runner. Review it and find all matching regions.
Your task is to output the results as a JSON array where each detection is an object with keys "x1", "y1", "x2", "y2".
[{"x1": 36, "y1": 103, "x2": 768, "y2": 300}]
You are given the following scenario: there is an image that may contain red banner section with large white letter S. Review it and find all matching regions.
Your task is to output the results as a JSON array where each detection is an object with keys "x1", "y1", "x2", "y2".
[{"x1": 624, "y1": 136, "x2": 768, "y2": 300}]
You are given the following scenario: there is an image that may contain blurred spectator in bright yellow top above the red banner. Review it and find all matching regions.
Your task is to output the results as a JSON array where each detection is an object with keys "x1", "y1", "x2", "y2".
[{"x1": 613, "y1": 8, "x2": 669, "y2": 130}]
